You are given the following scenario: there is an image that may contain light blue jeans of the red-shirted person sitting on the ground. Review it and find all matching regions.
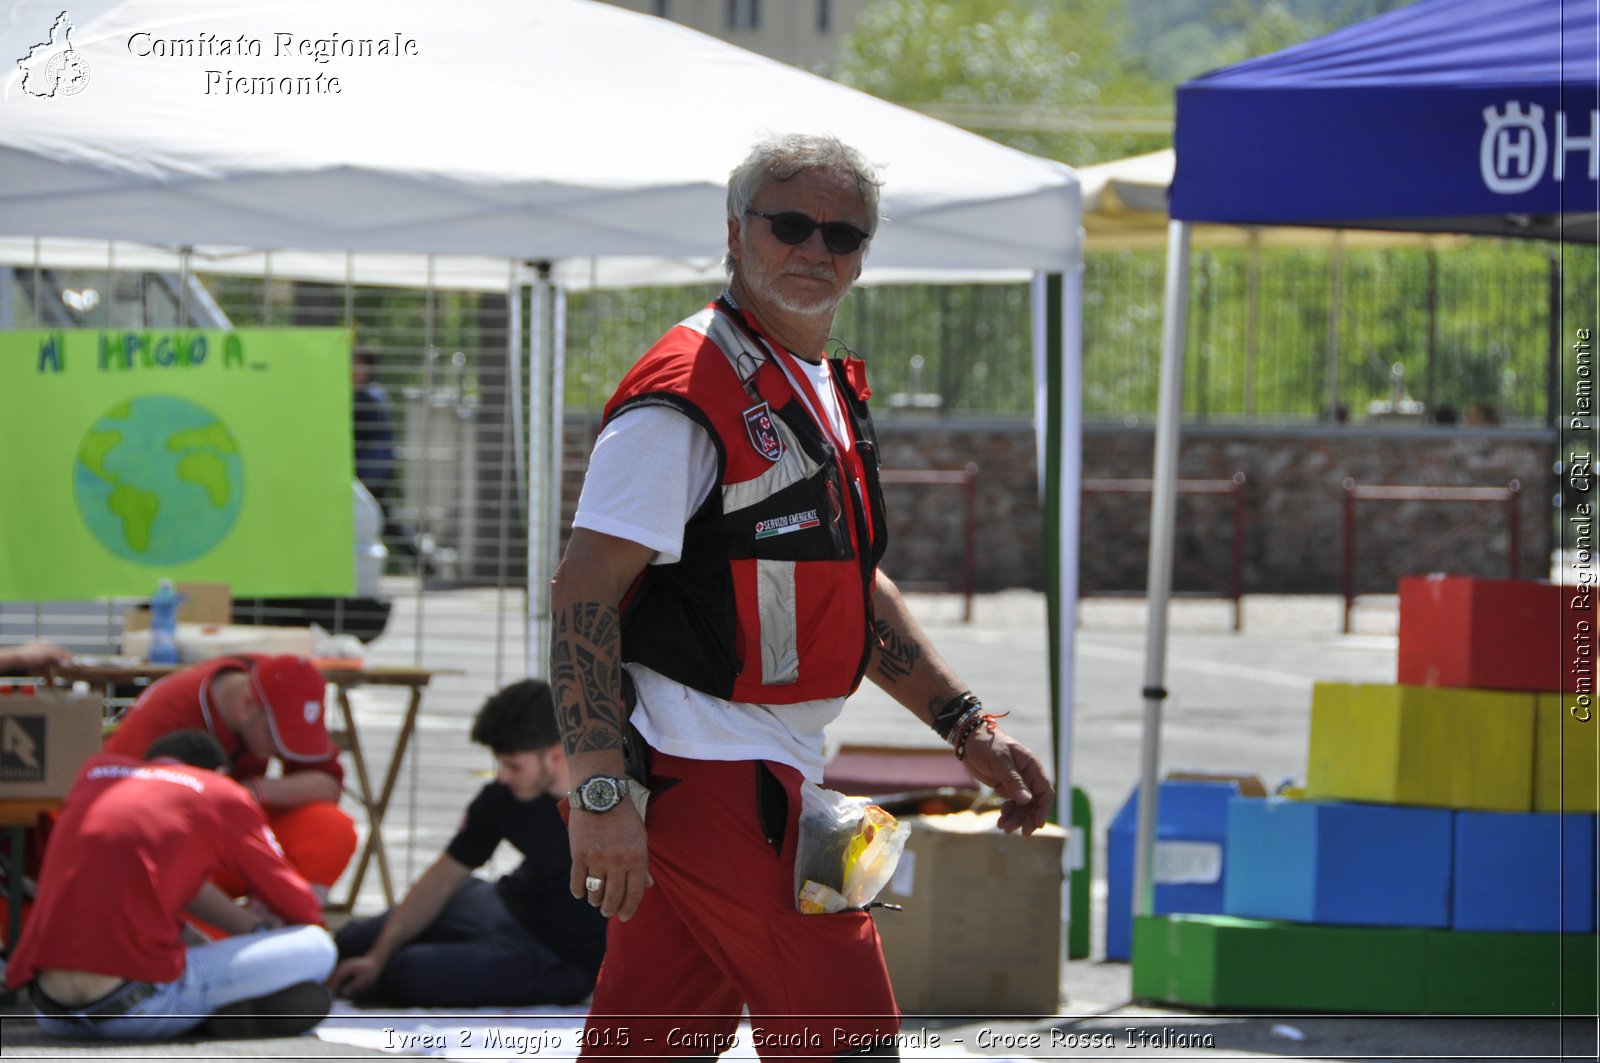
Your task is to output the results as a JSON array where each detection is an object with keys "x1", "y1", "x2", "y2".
[{"x1": 34, "y1": 927, "x2": 338, "y2": 1041}]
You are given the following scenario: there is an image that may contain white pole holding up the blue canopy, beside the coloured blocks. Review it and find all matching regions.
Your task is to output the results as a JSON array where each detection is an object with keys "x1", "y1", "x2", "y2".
[{"x1": 1133, "y1": 221, "x2": 1189, "y2": 916}]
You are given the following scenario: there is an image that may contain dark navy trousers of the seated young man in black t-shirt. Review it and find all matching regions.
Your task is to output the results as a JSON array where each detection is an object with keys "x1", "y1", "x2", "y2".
[{"x1": 334, "y1": 877, "x2": 594, "y2": 1007}]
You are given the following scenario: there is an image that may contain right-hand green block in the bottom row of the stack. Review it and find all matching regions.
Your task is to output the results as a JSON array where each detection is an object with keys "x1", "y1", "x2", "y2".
[{"x1": 1424, "y1": 930, "x2": 1600, "y2": 1015}]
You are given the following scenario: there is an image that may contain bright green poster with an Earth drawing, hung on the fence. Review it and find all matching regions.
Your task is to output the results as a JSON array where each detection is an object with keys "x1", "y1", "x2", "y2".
[{"x1": 0, "y1": 328, "x2": 355, "y2": 600}]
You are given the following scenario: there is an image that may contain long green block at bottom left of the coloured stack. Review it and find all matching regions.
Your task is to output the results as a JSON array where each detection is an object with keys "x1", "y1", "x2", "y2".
[{"x1": 1133, "y1": 916, "x2": 1426, "y2": 1013}]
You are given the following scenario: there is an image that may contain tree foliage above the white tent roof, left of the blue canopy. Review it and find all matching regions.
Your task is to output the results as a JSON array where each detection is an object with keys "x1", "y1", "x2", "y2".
[{"x1": 835, "y1": 0, "x2": 1410, "y2": 166}]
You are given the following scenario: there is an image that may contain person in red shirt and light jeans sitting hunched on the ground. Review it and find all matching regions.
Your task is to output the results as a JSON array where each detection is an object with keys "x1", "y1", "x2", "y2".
[{"x1": 6, "y1": 732, "x2": 336, "y2": 1039}]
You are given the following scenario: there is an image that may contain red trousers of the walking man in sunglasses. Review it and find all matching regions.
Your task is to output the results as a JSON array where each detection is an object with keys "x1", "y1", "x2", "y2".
[{"x1": 582, "y1": 752, "x2": 899, "y2": 1057}]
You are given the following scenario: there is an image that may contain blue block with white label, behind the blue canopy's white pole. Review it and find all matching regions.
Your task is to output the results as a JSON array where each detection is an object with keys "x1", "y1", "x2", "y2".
[{"x1": 1106, "y1": 780, "x2": 1238, "y2": 959}]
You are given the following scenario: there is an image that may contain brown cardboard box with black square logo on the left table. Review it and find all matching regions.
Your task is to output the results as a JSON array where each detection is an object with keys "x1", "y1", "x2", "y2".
[{"x1": 0, "y1": 693, "x2": 106, "y2": 800}]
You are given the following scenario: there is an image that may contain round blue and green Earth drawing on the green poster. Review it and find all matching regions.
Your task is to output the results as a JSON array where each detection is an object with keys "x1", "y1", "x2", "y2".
[{"x1": 74, "y1": 395, "x2": 245, "y2": 567}]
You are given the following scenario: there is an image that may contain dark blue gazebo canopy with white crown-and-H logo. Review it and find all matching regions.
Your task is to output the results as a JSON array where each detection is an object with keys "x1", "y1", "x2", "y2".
[{"x1": 1171, "y1": 0, "x2": 1600, "y2": 242}]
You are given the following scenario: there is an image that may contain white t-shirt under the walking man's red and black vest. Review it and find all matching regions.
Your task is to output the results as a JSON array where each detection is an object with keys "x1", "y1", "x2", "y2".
[{"x1": 573, "y1": 355, "x2": 850, "y2": 783}]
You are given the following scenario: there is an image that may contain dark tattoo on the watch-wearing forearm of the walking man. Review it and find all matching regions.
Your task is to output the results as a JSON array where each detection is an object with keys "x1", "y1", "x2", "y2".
[{"x1": 550, "y1": 602, "x2": 626, "y2": 754}]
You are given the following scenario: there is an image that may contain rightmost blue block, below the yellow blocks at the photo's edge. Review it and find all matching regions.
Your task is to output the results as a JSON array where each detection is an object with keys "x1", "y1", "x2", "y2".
[{"x1": 1451, "y1": 812, "x2": 1595, "y2": 933}]
